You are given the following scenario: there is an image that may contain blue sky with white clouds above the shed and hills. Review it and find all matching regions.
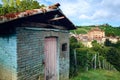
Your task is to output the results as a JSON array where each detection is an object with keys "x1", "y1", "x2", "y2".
[{"x1": 0, "y1": 0, "x2": 120, "y2": 26}]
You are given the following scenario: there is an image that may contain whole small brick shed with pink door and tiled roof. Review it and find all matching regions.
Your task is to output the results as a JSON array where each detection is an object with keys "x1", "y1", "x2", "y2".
[{"x1": 0, "y1": 4, "x2": 76, "y2": 80}]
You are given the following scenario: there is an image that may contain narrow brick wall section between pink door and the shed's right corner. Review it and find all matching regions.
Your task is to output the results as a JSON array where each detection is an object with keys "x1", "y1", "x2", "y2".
[{"x1": 59, "y1": 33, "x2": 69, "y2": 80}]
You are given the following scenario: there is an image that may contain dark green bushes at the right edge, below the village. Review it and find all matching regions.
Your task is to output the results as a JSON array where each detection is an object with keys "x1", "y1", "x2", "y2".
[{"x1": 104, "y1": 40, "x2": 120, "y2": 71}]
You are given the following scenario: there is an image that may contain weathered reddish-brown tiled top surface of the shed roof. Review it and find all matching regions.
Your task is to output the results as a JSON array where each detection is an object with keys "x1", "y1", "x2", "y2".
[{"x1": 0, "y1": 3, "x2": 60, "y2": 23}]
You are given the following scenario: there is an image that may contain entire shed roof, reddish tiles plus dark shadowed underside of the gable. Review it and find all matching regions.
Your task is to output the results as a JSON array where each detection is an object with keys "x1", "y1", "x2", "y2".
[{"x1": 0, "y1": 3, "x2": 76, "y2": 30}]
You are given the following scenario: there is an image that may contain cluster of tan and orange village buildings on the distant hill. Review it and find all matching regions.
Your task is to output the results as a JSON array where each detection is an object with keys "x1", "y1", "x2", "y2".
[{"x1": 70, "y1": 26, "x2": 120, "y2": 47}]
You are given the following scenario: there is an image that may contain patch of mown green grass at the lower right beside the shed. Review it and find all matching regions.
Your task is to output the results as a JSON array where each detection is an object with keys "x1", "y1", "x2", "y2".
[{"x1": 70, "y1": 70, "x2": 120, "y2": 80}]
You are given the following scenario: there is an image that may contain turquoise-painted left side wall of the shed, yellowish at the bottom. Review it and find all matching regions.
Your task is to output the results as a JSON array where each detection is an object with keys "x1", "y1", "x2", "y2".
[{"x1": 0, "y1": 35, "x2": 17, "y2": 80}]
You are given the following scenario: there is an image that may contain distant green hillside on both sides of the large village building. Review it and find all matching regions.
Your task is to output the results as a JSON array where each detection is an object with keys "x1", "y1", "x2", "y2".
[{"x1": 71, "y1": 25, "x2": 120, "y2": 36}]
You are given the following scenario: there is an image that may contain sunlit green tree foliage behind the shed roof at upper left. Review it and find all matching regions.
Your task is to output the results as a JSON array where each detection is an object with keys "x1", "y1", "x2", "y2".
[{"x1": 0, "y1": 0, "x2": 44, "y2": 15}]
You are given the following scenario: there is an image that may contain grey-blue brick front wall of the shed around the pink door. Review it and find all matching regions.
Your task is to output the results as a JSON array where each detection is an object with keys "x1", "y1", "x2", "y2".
[{"x1": 17, "y1": 28, "x2": 69, "y2": 80}]
